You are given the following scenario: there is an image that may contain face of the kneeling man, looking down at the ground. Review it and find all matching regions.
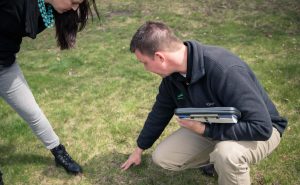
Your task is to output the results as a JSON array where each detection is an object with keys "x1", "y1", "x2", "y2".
[{"x1": 134, "y1": 50, "x2": 171, "y2": 78}]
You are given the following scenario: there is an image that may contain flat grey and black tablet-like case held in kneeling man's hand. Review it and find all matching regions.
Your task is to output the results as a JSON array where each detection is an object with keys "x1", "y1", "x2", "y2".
[{"x1": 175, "y1": 107, "x2": 241, "y2": 123}]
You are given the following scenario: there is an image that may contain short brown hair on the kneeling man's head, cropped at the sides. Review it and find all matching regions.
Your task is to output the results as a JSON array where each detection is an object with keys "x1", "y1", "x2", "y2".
[{"x1": 130, "y1": 21, "x2": 182, "y2": 57}]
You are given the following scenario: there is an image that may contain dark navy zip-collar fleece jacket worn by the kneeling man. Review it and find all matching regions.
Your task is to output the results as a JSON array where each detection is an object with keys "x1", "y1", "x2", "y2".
[{"x1": 137, "y1": 41, "x2": 287, "y2": 149}]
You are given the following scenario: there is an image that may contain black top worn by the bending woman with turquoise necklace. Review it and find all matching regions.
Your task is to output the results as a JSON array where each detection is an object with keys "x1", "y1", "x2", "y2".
[{"x1": 0, "y1": 0, "x2": 45, "y2": 67}]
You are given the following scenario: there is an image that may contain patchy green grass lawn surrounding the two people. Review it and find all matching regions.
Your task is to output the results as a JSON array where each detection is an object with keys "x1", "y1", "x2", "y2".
[{"x1": 0, "y1": 0, "x2": 300, "y2": 185}]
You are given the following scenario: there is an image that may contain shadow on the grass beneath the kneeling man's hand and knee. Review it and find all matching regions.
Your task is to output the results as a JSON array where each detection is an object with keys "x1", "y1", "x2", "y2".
[{"x1": 84, "y1": 152, "x2": 217, "y2": 185}]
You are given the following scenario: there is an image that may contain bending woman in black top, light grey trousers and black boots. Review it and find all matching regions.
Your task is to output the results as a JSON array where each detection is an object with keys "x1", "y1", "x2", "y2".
[{"x1": 0, "y1": 0, "x2": 99, "y2": 184}]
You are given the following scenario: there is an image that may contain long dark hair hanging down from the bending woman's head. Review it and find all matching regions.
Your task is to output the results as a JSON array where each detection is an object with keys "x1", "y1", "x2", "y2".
[{"x1": 54, "y1": 0, "x2": 100, "y2": 50}]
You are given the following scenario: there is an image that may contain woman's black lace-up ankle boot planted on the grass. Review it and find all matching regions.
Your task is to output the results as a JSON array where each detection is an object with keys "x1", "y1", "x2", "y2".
[{"x1": 51, "y1": 144, "x2": 82, "y2": 175}]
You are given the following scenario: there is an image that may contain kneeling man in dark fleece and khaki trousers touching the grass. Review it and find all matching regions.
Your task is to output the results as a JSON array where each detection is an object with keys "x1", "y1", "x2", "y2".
[{"x1": 121, "y1": 22, "x2": 287, "y2": 185}]
